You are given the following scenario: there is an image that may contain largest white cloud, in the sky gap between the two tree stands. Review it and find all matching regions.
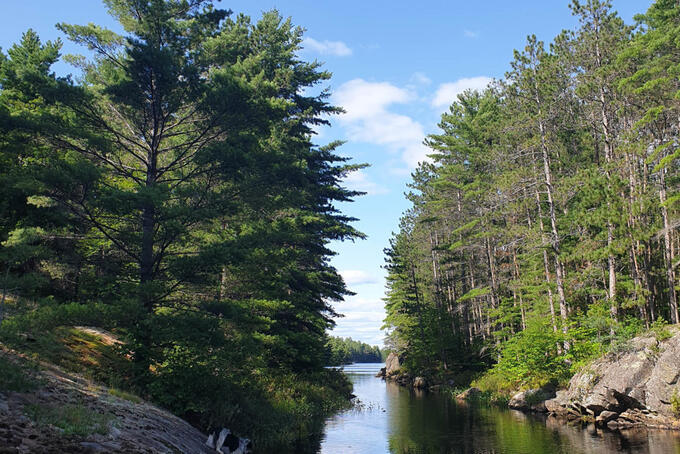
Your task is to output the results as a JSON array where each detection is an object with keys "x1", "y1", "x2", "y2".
[{"x1": 333, "y1": 79, "x2": 427, "y2": 168}]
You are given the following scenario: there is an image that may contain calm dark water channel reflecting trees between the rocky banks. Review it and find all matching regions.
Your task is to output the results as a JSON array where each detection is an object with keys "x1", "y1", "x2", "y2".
[{"x1": 319, "y1": 364, "x2": 680, "y2": 454}]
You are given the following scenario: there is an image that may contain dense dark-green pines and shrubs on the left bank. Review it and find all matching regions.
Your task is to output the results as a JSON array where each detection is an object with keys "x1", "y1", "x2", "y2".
[{"x1": 0, "y1": 0, "x2": 362, "y2": 449}]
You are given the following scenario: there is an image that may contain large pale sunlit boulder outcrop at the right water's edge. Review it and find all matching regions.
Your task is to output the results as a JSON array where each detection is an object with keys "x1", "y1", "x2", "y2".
[{"x1": 545, "y1": 327, "x2": 680, "y2": 429}]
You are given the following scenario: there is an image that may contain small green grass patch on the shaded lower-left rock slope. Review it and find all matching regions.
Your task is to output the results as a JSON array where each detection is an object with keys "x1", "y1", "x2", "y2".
[{"x1": 24, "y1": 405, "x2": 114, "y2": 437}]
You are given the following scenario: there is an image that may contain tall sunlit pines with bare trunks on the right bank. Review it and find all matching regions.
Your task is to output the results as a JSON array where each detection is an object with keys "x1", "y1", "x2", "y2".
[{"x1": 385, "y1": 0, "x2": 680, "y2": 389}]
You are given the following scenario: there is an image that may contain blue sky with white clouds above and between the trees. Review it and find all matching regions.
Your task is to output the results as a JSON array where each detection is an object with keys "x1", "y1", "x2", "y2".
[{"x1": 0, "y1": 0, "x2": 652, "y2": 345}]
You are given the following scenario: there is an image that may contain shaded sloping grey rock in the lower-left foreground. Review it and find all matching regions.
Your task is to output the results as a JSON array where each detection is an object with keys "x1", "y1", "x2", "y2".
[{"x1": 0, "y1": 348, "x2": 224, "y2": 454}]
